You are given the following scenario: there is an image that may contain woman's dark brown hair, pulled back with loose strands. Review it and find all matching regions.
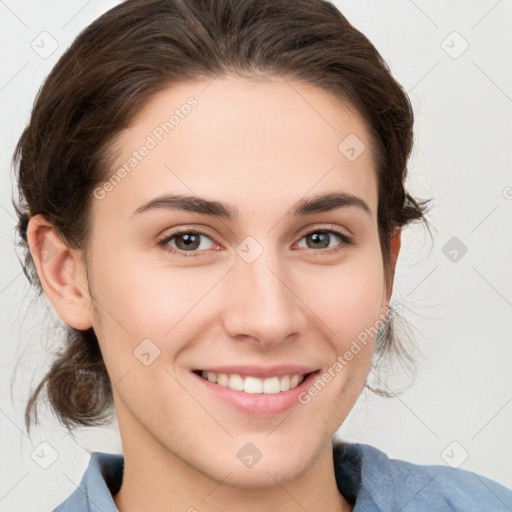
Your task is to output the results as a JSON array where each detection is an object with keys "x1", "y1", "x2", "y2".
[{"x1": 13, "y1": 0, "x2": 429, "y2": 431}]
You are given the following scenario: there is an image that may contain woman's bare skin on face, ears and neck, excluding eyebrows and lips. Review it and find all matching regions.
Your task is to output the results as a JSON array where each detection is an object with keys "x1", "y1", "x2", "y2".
[{"x1": 28, "y1": 76, "x2": 400, "y2": 512}]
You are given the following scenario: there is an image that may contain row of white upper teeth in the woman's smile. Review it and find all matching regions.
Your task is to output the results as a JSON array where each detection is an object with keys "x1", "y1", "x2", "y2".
[{"x1": 201, "y1": 371, "x2": 304, "y2": 395}]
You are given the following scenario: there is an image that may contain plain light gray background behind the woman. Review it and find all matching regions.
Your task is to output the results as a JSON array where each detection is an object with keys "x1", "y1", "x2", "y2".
[{"x1": 0, "y1": 0, "x2": 512, "y2": 512}]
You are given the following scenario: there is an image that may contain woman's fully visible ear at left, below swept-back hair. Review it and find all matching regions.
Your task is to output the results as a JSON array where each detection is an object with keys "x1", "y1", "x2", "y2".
[{"x1": 27, "y1": 215, "x2": 92, "y2": 330}]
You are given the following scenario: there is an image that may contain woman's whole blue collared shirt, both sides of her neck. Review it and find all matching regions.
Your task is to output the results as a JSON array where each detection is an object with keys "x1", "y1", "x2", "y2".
[{"x1": 53, "y1": 443, "x2": 512, "y2": 512}]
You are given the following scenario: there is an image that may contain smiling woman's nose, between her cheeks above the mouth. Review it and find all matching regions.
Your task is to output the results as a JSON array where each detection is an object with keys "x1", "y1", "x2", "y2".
[{"x1": 224, "y1": 243, "x2": 307, "y2": 347}]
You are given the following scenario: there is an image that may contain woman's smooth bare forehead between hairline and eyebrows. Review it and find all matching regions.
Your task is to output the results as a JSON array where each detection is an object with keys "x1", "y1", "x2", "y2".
[{"x1": 96, "y1": 76, "x2": 377, "y2": 224}]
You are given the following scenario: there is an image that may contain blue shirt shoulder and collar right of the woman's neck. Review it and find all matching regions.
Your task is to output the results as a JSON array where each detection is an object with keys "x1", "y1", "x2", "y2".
[{"x1": 334, "y1": 443, "x2": 512, "y2": 512}]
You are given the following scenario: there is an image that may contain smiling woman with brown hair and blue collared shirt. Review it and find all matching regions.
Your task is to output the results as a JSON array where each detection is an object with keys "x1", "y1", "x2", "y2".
[{"x1": 15, "y1": 0, "x2": 512, "y2": 512}]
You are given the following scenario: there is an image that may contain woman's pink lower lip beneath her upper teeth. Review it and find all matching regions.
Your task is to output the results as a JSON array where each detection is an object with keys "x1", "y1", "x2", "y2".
[{"x1": 192, "y1": 371, "x2": 319, "y2": 416}]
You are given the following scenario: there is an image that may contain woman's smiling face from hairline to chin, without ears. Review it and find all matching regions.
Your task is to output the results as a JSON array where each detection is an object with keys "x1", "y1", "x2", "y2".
[{"x1": 73, "y1": 76, "x2": 396, "y2": 486}]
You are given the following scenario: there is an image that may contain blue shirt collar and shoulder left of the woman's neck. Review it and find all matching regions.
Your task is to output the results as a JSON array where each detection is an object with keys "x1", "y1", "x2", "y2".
[{"x1": 53, "y1": 452, "x2": 124, "y2": 512}]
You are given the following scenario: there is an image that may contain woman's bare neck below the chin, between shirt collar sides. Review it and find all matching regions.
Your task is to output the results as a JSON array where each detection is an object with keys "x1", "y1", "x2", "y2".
[{"x1": 114, "y1": 412, "x2": 352, "y2": 512}]
